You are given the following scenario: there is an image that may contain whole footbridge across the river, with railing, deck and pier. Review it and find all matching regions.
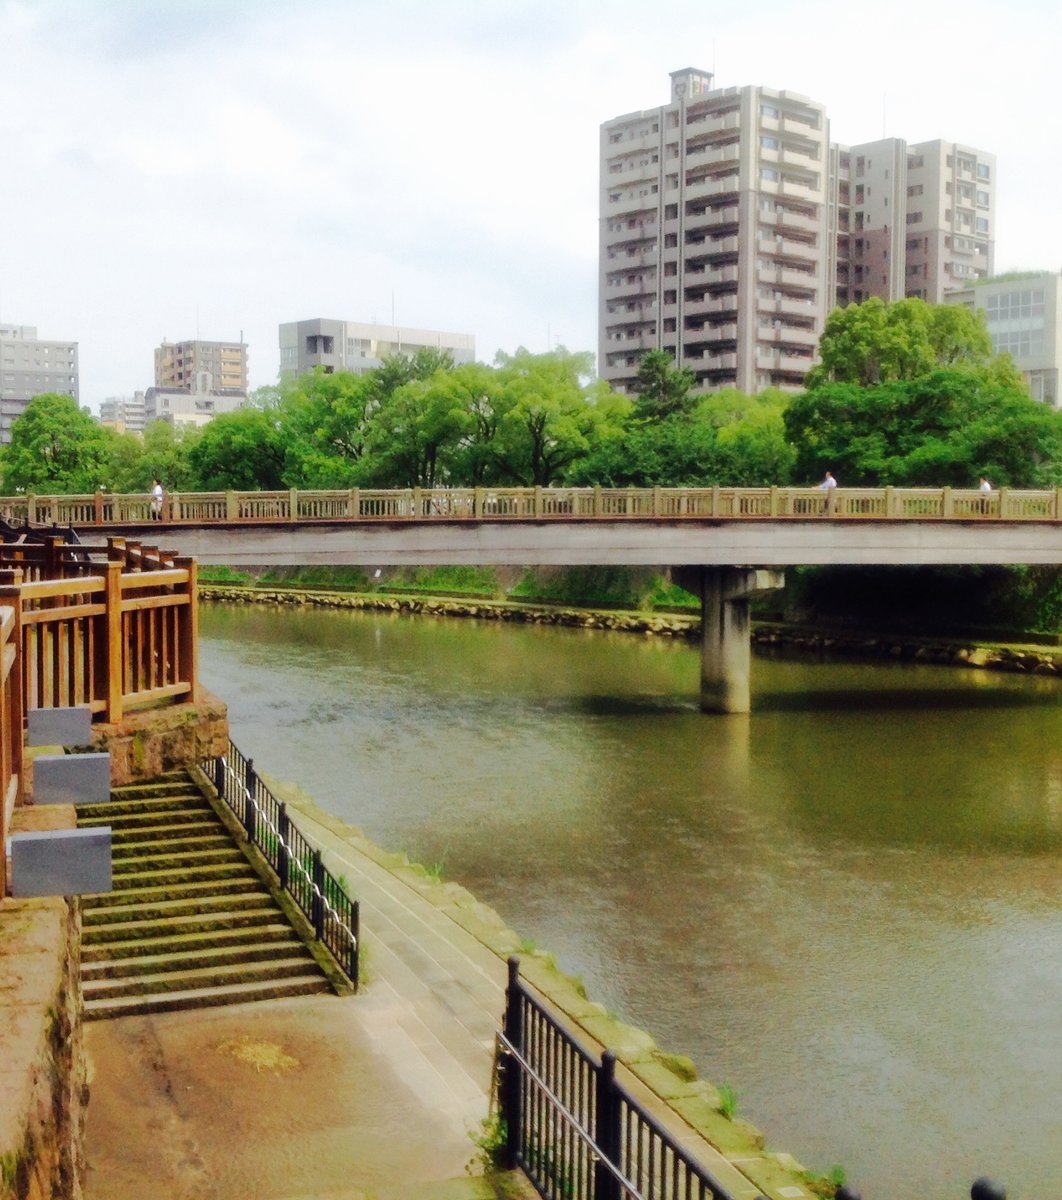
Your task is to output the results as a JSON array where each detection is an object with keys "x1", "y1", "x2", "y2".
[{"x1": 10, "y1": 487, "x2": 1062, "y2": 713}]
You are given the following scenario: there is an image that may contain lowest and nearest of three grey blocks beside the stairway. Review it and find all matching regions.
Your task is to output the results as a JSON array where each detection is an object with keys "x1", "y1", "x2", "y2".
[{"x1": 10, "y1": 826, "x2": 110, "y2": 896}]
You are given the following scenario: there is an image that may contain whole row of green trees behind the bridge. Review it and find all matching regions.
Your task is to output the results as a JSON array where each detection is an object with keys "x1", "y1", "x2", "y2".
[{"x1": 0, "y1": 299, "x2": 1062, "y2": 494}]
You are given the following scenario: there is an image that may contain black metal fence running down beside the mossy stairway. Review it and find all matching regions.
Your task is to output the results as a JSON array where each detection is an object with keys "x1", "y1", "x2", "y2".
[{"x1": 202, "y1": 742, "x2": 359, "y2": 988}]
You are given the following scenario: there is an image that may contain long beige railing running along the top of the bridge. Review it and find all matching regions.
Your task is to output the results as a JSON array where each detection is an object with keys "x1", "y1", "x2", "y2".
[{"x1": 0, "y1": 487, "x2": 1062, "y2": 529}]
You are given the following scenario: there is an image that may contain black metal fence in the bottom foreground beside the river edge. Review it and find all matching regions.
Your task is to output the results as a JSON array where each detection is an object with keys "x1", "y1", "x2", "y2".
[{"x1": 500, "y1": 958, "x2": 733, "y2": 1200}]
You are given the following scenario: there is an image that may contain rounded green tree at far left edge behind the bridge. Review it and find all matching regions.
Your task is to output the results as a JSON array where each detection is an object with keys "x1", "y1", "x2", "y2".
[{"x1": 2, "y1": 392, "x2": 112, "y2": 494}]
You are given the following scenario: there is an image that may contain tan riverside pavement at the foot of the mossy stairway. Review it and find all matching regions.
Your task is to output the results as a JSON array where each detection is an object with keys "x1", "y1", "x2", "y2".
[{"x1": 85, "y1": 796, "x2": 518, "y2": 1200}]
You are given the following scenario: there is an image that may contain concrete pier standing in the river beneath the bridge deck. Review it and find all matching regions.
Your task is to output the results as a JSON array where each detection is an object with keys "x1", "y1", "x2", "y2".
[{"x1": 672, "y1": 566, "x2": 785, "y2": 713}]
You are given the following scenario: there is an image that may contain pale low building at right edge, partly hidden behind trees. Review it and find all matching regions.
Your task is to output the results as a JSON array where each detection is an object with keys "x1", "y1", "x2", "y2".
[{"x1": 947, "y1": 271, "x2": 1062, "y2": 408}]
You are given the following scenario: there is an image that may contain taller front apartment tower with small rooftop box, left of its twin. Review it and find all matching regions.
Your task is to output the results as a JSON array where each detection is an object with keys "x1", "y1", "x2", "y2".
[{"x1": 599, "y1": 68, "x2": 829, "y2": 391}]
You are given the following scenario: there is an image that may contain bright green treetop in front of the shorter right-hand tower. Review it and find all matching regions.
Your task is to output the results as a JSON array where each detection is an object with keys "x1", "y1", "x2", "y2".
[{"x1": 805, "y1": 296, "x2": 992, "y2": 390}]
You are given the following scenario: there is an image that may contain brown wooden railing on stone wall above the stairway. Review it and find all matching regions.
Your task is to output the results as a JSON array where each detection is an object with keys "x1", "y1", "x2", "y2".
[{"x1": 0, "y1": 539, "x2": 198, "y2": 724}]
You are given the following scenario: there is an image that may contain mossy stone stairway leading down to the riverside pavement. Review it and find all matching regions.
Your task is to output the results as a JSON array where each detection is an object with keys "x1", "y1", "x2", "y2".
[{"x1": 78, "y1": 773, "x2": 331, "y2": 1019}]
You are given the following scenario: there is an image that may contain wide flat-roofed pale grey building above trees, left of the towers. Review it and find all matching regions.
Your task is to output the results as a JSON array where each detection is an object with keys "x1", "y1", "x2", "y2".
[{"x1": 280, "y1": 317, "x2": 475, "y2": 376}]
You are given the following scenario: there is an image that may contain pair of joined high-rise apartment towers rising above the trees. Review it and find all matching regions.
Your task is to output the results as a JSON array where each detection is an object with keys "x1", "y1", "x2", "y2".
[{"x1": 598, "y1": 67, "x2": 995, "y2": 391}]
